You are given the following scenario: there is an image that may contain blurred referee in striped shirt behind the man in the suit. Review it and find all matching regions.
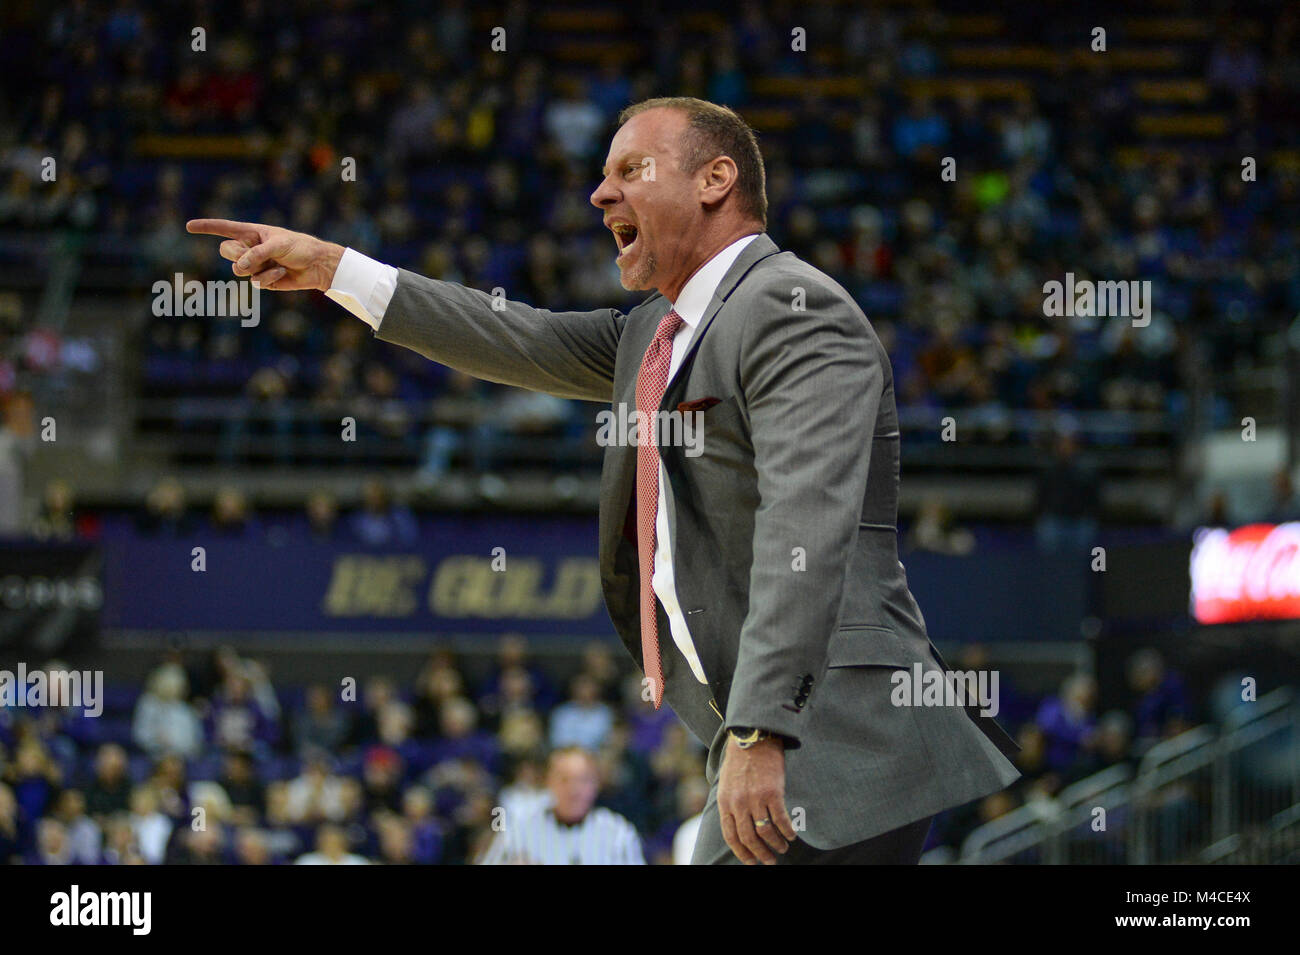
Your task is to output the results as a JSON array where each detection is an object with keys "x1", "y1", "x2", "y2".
[{"x1": 480, "y1": 746, "x2": 645, "y2": 865}]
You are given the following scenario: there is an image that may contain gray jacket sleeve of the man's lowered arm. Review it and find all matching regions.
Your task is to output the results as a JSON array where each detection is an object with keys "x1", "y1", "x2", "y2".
[{"x1": 725, "y1": 277, "x2": 887, "y2": 746}]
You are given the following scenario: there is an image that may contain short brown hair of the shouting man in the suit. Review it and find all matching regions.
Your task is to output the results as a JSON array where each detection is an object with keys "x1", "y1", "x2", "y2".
[{"x1": 619, "y1": 96, "x2": 767, "y2": 229}]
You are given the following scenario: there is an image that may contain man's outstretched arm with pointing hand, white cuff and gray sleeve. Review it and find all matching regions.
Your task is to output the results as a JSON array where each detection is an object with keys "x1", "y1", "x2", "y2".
[{"x1": 186, "y1": 218, "x2": 627, "y2": 401}]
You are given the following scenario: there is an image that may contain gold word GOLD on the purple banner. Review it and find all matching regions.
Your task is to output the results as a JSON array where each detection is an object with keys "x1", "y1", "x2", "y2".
[{"x1": 429, "y1": 556, "x2": 601, "y2": 620}]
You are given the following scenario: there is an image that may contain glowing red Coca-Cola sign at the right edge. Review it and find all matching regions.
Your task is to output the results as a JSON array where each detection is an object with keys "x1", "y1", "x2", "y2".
[{"x1": 1191, "y1": 521, "x2": 1300, "y2": 624}]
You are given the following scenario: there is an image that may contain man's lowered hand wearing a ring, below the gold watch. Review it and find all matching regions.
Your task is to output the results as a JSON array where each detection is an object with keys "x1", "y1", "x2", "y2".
[{"x1": 718, "y1": 738, "x2": 796, "y2": 865}]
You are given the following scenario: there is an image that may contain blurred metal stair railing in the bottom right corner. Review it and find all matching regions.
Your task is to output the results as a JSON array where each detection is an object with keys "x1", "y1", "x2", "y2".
[{"x1": 958, "y1": 689, "x2": 1300, "y2": 865}]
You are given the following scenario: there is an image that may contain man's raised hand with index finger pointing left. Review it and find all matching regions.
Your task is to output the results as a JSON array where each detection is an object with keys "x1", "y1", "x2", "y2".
[{"x1": 185, "y1": 218, "x2": 343, "y2": 292}]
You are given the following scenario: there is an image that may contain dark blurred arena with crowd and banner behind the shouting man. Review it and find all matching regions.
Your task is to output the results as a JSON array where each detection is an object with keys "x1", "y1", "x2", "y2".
[{"x1": 0, "y1": 0, "x2": 1300, "y2": 899}]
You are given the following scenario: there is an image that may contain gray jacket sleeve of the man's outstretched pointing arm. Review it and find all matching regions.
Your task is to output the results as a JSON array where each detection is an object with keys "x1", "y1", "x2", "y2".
[{"x1": 374, "y1": 269, "x2": 627, "y2": 401}]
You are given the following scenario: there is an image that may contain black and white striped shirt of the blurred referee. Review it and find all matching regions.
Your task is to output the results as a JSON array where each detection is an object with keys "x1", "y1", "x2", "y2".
[{"x1": 478, "y1": 806, "x2": 645, "y2": 865}]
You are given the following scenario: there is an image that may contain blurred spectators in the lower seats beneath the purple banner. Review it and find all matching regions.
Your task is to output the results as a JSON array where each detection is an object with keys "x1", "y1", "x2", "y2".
[{"x1": 0, "y1": 635, "x2": 1199, "y2": 864}]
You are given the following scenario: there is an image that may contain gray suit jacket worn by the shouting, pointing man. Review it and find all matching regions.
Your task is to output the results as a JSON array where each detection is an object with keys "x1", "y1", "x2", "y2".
[{"x1": 376, "y1": 235, "x2": 1019, "y2": 848}]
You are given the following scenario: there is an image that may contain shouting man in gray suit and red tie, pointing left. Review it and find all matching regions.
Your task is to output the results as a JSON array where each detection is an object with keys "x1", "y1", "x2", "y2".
[{"x1": 187, "y1": 97, "x2": 1018, "y2": 864}]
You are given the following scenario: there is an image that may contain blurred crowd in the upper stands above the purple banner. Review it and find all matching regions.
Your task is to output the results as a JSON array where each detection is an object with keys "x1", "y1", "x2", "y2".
[{"x1": 0, "y1": 0, "x2": 1300, "y2": 474}]
